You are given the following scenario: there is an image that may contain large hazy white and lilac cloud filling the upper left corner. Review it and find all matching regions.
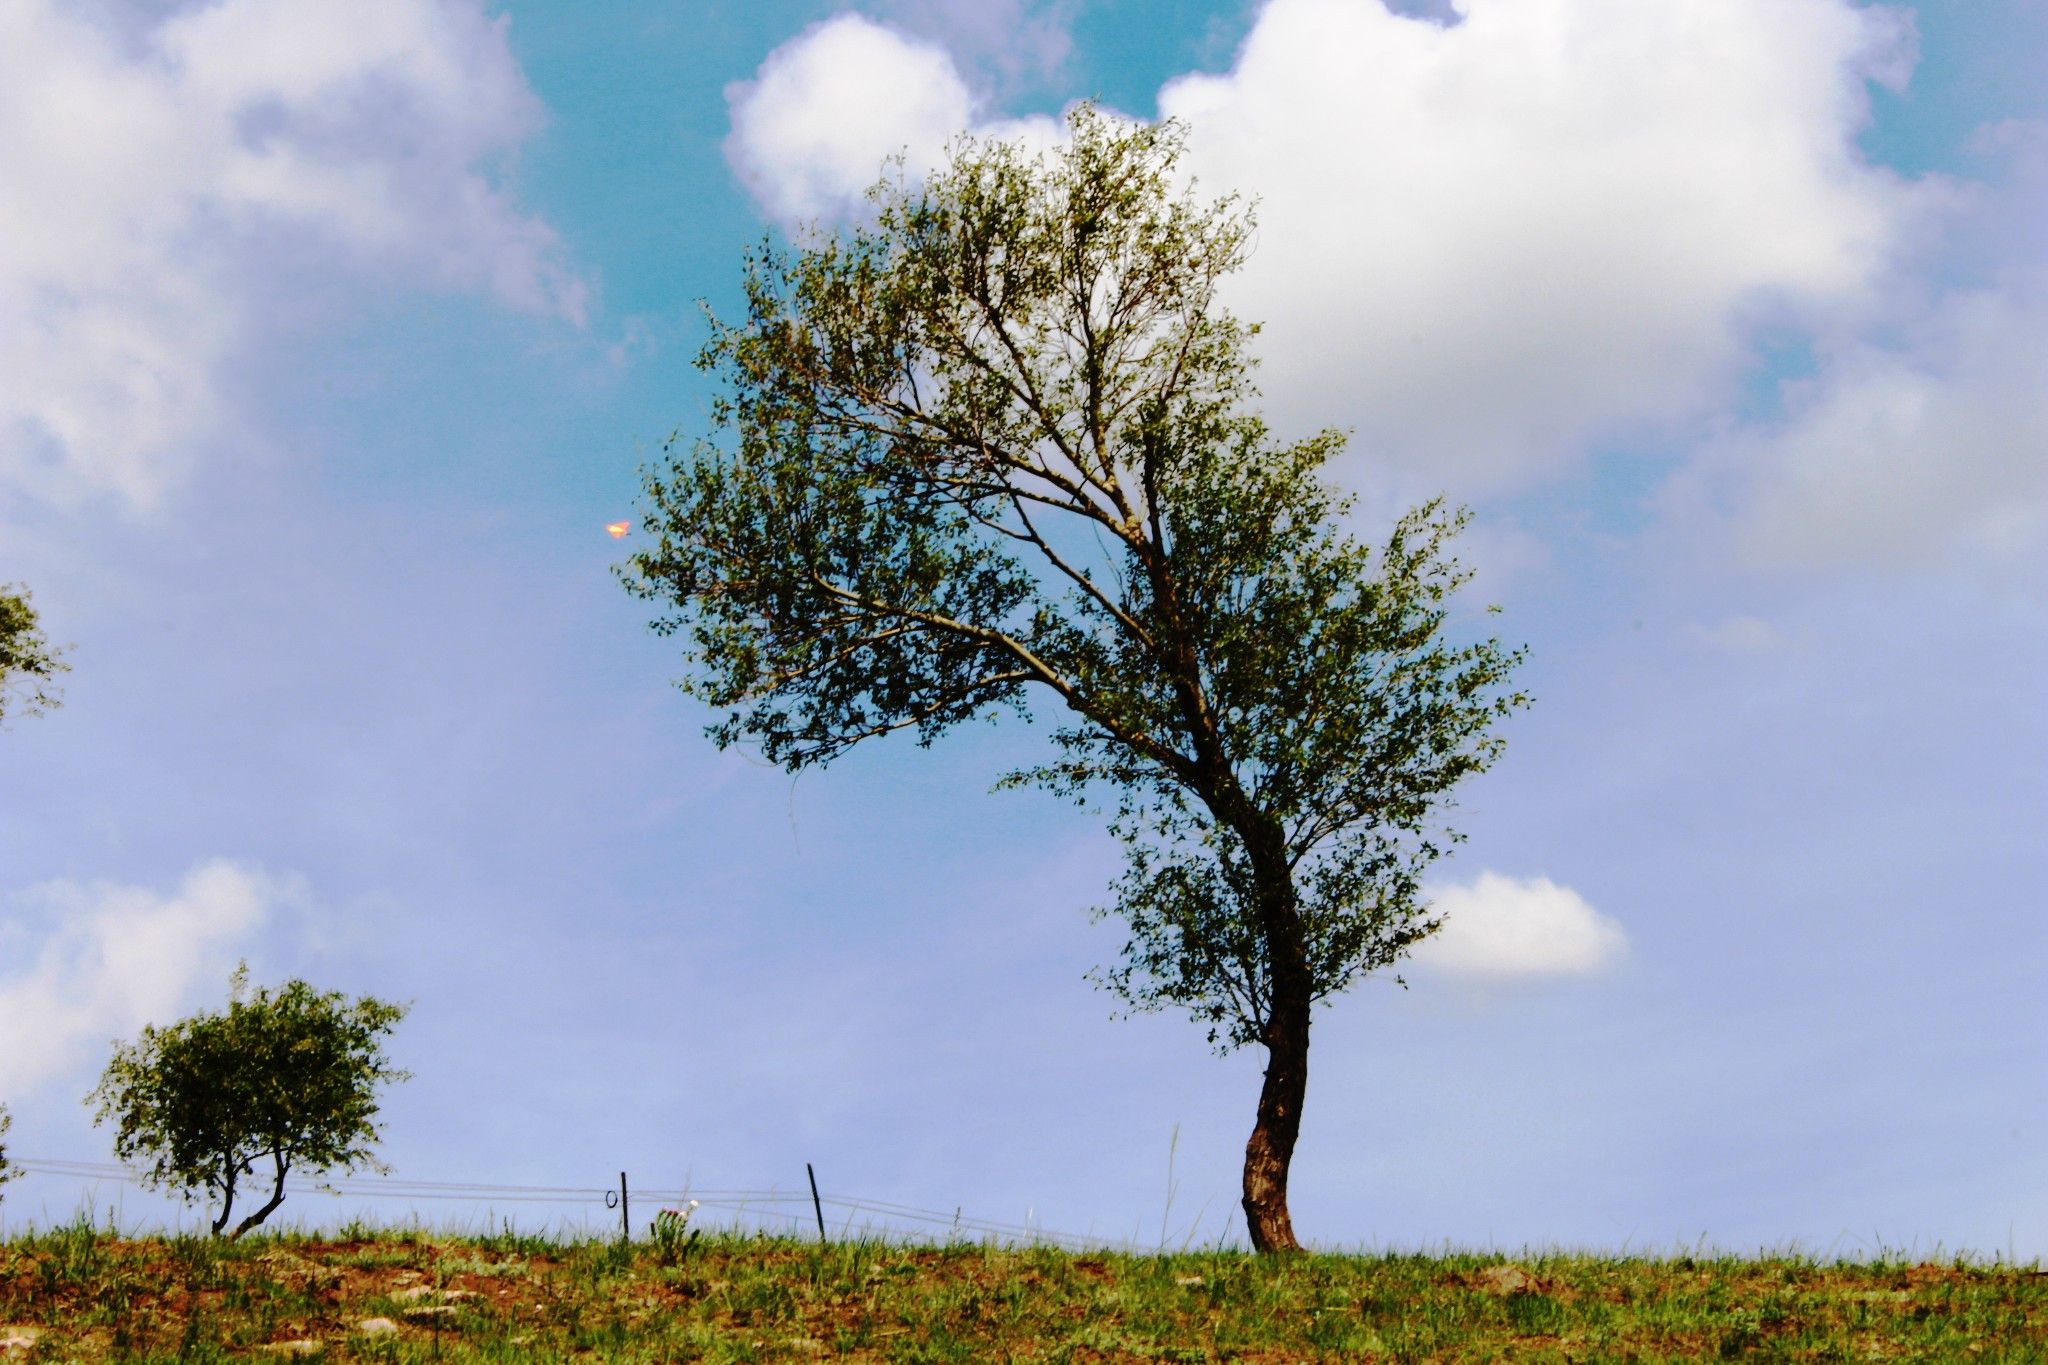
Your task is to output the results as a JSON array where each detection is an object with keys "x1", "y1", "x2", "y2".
[{"x1": 0, "y1": 0, "x2": 584, "y2": 510}]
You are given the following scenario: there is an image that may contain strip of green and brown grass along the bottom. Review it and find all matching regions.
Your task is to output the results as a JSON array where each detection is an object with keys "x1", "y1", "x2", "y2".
[{"x1": 0, "y1": 1220, "x2": 2048, "y2": 1365}]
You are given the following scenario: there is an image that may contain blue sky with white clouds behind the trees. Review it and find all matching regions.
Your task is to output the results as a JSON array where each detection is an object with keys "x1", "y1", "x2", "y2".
[{"x1": 0, "y1": 0, "x2": 2048, "y2": 1259}]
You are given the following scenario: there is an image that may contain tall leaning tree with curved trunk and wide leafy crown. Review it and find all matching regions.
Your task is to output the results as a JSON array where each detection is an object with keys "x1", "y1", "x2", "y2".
[{"x1": 621, "y1": 106, "x2": 1526, "y2": 1250}]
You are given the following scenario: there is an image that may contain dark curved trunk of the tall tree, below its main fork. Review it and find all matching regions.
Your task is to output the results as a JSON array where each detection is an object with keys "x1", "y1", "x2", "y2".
[{"x1": 1243, "y1": 833, "x2": 1313, "y2": 1252}]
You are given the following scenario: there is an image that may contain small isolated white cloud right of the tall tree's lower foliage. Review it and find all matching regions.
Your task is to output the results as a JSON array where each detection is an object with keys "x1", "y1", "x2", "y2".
[{"x1": 1411, "y1": 872, "x2": 1628, "y2": 982}]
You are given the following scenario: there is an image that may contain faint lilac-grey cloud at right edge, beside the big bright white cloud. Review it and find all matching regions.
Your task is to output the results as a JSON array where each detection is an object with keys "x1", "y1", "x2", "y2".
[{"x1": 1667, "y1": 125, "x2": 2048, "y2": 577}]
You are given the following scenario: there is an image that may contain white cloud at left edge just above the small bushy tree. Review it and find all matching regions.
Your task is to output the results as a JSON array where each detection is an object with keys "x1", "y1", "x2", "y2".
[{"x1": 0, "y1": 860, "x2": 299, "y2": 1095}]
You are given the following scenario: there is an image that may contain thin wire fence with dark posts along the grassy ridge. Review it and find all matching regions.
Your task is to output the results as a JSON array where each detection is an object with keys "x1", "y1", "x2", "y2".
[{"x1": 8, "y1": 1156, "x2": 1192, "y2": 1252}]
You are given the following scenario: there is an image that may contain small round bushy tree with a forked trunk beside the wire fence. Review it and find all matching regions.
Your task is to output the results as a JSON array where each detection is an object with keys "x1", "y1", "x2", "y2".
[{"x1": 86, "y1": 968, "x2": 408, "y2": 1238}]
